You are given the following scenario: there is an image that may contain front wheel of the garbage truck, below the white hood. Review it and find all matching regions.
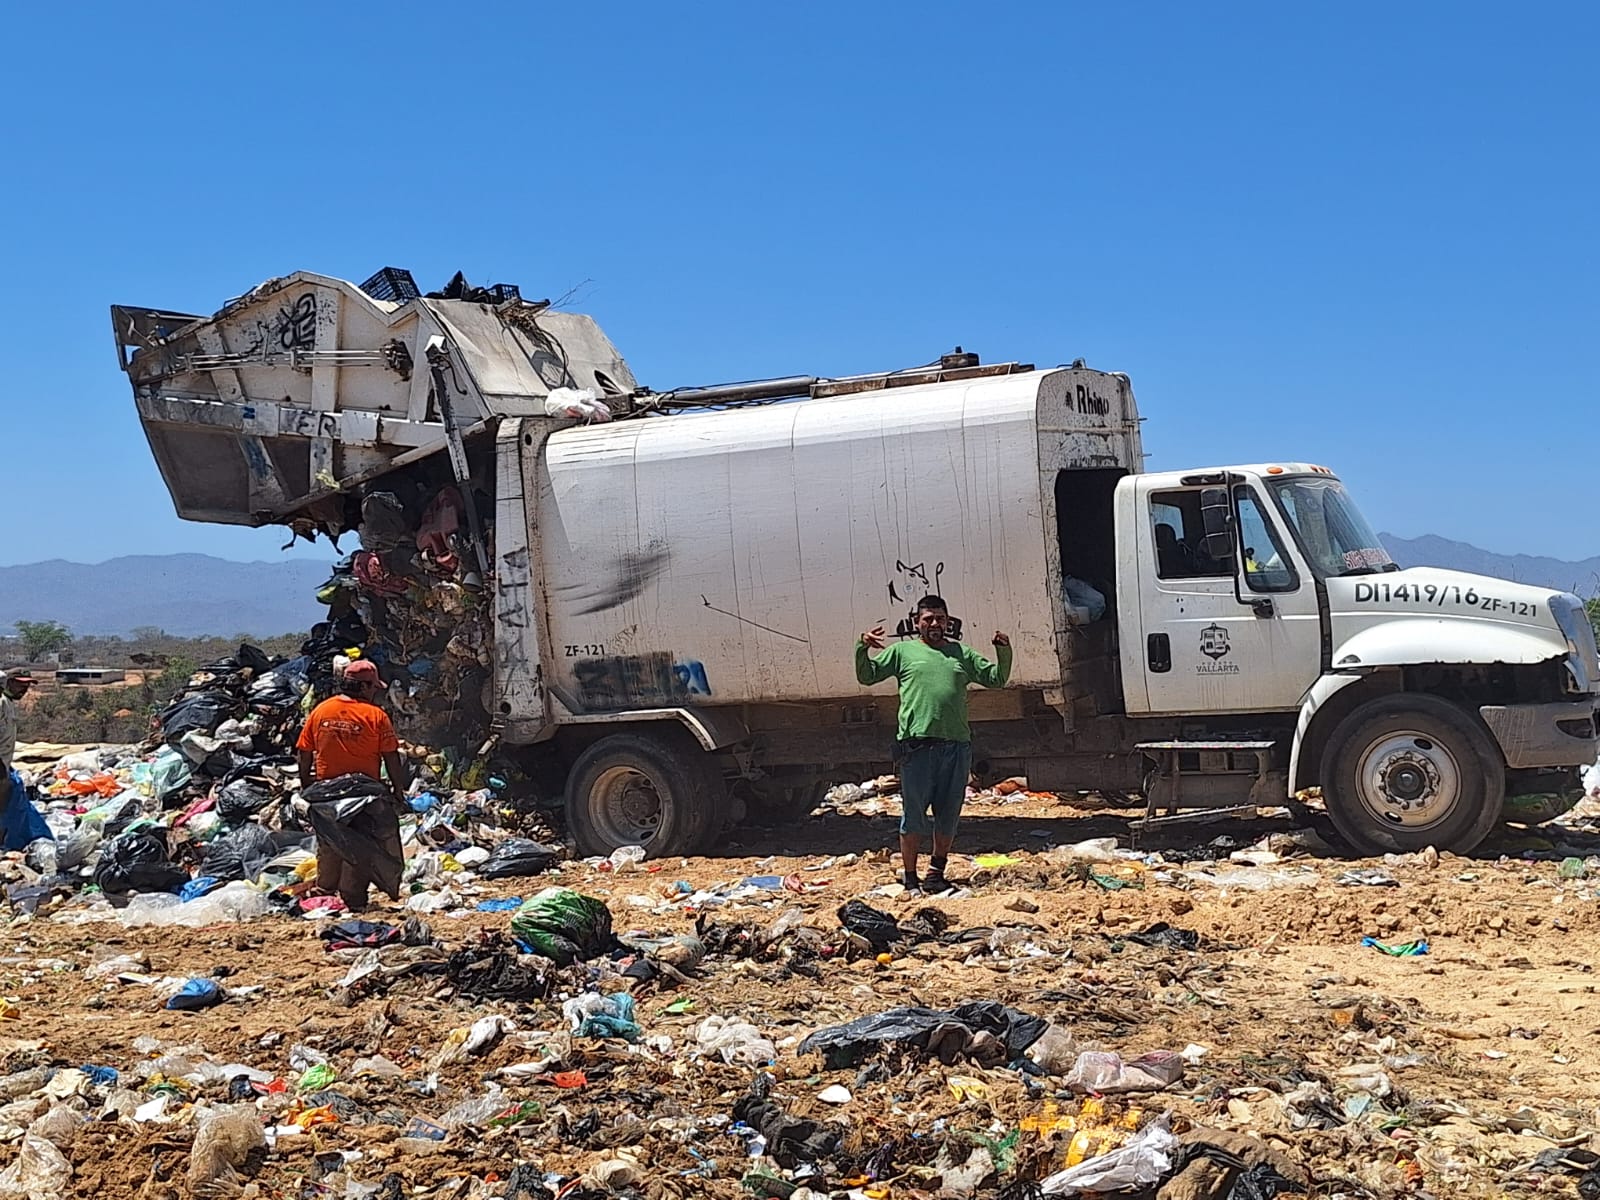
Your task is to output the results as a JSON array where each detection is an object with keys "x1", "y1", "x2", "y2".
[{"x1": 1322, "y1": 693, "x2": 1506, "y2": 854}]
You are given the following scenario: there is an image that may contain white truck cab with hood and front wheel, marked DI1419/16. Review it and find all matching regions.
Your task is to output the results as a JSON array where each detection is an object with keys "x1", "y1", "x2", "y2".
[{"x1": 1117, "y1": 462, "x2": 1600, "y2": 850}]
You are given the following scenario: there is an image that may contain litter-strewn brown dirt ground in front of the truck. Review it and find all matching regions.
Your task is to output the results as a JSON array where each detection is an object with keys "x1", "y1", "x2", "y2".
[{"x1": 0, "y1": 794, "x2": 1600, "y2": 1200}]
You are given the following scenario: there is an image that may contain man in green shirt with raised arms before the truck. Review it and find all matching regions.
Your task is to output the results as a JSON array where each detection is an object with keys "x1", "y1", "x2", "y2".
[{"x1": 856, "y1": 595, "x2": 1011, "y2": 894}]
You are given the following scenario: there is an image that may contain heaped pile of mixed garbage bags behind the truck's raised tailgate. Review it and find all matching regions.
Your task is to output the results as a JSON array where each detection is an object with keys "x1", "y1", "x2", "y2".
[{"x1": 0, "y1": 638, "x2": 566, "y2": 925}]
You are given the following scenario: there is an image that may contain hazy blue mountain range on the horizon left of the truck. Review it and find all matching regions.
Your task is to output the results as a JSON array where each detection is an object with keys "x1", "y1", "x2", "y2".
[{"x1": 0, "y1": 554, "x2": 330, "y2": 637}]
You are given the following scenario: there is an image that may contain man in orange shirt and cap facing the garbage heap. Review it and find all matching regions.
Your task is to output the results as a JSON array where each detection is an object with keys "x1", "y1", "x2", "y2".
[{"x1": 294, "y1": 659, "x2": 410, "y2": 912}]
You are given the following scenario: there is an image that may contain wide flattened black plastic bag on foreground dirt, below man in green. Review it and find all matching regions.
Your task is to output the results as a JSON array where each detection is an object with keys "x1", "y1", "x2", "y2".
[{"x1": 800, "y1": 1000, "x2": 1050, "y2": 1070}]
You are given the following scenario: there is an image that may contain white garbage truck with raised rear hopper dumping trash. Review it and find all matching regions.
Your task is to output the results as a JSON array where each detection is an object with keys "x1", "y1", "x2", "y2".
[{"x1": 112, "y1": 269, "x2": 1600, "y2": 856}]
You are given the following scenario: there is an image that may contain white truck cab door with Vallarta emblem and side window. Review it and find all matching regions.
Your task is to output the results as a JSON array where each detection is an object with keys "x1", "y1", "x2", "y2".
[{"x1": 1128, "y1": 475, "x2": 1322, "y2": 714}]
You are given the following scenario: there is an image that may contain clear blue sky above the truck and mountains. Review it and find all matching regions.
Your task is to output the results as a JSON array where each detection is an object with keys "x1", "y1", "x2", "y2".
[{"x1": 0, "y1": 2, "x2": 1600, "y2": 563}]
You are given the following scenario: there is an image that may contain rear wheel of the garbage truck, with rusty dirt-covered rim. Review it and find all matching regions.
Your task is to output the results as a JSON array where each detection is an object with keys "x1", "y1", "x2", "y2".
[{"x1": 566, "y1": 733, "x2": 728, "y2": 858}]
